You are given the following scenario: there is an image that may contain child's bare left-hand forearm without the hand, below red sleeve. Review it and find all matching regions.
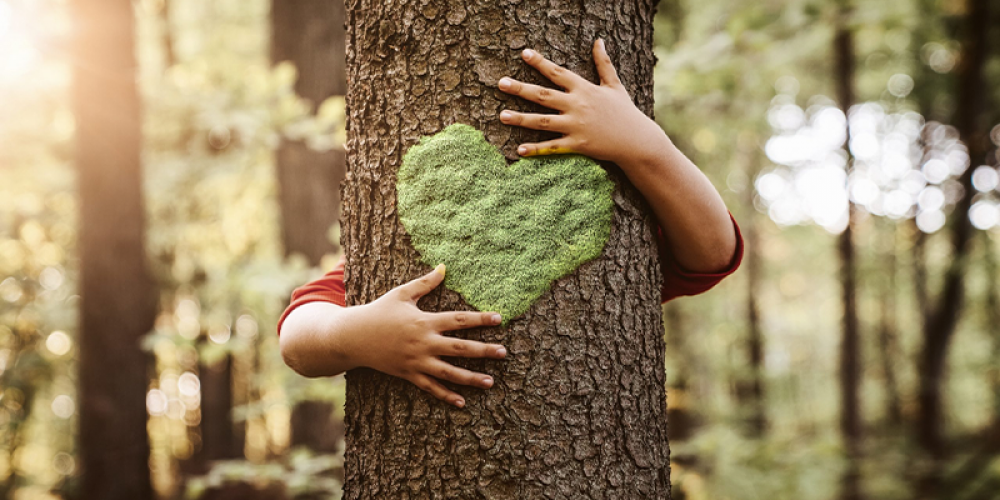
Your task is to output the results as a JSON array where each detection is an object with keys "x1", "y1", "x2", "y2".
[{"x1": 279, "y1": 302, "x2": 360, "y2": 377}]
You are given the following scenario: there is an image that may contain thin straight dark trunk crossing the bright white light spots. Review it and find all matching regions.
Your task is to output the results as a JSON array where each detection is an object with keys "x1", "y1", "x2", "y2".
[{"x1": 834, "y1": 4, "x2": 862, "y2": 500}]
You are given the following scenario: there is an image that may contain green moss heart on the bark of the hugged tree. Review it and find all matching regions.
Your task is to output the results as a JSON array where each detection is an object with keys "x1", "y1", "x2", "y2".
[{"x1": 396, "y1": 124, "x2": 614, "y2": 324}]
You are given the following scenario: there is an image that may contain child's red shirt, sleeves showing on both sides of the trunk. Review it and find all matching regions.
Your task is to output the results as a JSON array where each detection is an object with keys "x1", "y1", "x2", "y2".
[{"x1": 278, "y1": 214, "x2": 743, "y2": 333}]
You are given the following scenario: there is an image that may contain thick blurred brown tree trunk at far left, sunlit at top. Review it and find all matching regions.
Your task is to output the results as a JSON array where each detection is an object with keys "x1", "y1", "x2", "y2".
[{"x1": 71, "y1": 0, "x2": 156, "y2": 500}]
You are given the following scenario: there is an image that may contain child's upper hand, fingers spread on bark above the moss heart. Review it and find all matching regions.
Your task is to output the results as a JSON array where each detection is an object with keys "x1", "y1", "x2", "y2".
[{"x1": 498, "y1": 40, "x2": 669, "y2": 169}]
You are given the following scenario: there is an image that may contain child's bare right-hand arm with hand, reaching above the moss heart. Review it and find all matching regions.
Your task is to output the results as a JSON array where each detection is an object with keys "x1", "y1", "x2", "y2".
[{"x1": 499, "y1": 40, "x2": 737, "y2": 272}]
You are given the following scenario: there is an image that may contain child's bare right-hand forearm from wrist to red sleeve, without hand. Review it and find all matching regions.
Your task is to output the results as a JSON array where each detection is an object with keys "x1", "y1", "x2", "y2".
[{"x1": 619, "y1": 124, "x2": 736, "y2": 272}]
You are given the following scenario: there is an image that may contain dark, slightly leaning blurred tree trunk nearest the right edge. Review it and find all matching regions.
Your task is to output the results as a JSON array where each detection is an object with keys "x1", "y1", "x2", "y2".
[{"x1": 918, "y1": 0, "x2": 989, "y2": 459}]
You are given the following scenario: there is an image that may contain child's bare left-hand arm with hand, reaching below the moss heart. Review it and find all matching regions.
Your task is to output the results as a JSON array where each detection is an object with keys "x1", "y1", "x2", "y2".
[{"x1": 280, "y1": 264, "x2": 507, "y2": 407}]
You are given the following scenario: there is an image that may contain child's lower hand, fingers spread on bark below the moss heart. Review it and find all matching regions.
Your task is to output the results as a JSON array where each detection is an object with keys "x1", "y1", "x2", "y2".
[{"x1": 345, "y1": 264, "x2": 507, "y2": 407}]
